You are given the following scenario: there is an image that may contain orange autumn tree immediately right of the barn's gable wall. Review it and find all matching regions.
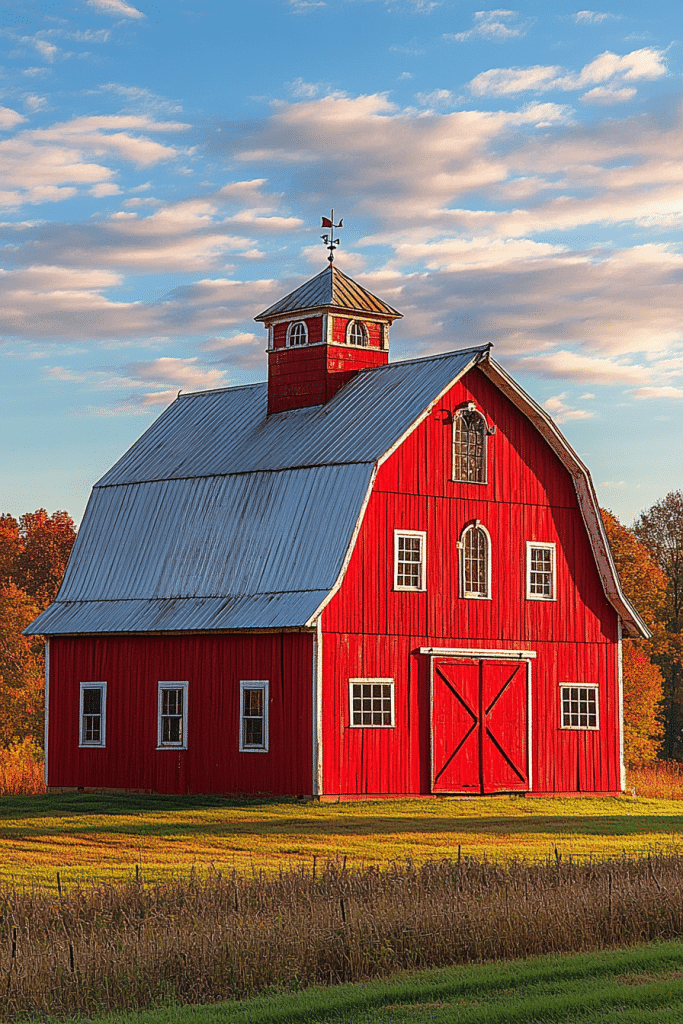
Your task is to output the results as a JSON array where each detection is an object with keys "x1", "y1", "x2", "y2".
[{"x1": 601, "y1": 509, "x2": 669, "y2": 765}]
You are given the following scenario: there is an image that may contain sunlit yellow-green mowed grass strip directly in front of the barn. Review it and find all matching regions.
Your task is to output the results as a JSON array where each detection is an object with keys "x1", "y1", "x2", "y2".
[{"x1": 0, "y1": 794, "x2": 683, "y2": 886}]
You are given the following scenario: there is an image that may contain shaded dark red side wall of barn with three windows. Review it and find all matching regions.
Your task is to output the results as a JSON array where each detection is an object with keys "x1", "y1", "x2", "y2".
[{"x1": 48, "y1": 633, "x2": 312, "y2": 795}]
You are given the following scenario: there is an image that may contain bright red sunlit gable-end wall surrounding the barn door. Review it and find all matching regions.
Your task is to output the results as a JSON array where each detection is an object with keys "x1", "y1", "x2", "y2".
[{"x1": 323, "y1": 369, "x2": 621, "y2": 794}]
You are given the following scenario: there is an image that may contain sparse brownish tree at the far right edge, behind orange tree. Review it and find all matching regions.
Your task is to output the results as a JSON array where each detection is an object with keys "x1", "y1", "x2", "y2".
[{"x1": 634, "y1": 490, "x2": 683, "y2": 760}]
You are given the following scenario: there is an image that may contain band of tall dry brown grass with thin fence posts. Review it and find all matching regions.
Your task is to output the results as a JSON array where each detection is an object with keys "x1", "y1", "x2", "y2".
[{"x1": 0, "y1": 854, "x2": 683, "y2": 1020}]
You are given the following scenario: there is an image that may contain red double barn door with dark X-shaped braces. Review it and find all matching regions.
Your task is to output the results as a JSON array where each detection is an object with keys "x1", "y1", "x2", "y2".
[{"x1": 432, "y1": 657, "x2": 529, "y2": 794}]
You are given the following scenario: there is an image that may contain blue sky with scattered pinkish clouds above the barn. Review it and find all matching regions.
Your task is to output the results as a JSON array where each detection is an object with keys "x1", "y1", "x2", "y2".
[{"x1": 0, "y1": 0, "x2": 683, "y2": 523}]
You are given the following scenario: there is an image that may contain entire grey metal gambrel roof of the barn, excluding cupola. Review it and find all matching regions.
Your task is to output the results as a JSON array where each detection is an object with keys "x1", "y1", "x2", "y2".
[{"x1": 30, "y1": 348, "x2": 647, "y2": 636}]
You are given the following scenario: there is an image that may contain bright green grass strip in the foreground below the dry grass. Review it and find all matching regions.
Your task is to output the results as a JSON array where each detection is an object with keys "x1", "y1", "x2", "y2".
[{"x1": 45, "y1": 942, "x2": 683, "y2": 1024}]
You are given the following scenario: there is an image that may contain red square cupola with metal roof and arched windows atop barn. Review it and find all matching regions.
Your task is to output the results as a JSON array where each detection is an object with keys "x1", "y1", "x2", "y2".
[{"x1": 254, "y1": 260, "x2": 401, "y2": 414}]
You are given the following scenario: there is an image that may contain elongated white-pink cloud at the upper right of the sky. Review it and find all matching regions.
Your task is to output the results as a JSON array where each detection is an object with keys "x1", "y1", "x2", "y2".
[{"x1": 469, "y1": 46, "x2": 667, "y2": 96}]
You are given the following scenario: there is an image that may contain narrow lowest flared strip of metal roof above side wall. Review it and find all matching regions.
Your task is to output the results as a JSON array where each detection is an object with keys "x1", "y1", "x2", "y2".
[{"x1": 26, "y1": 591, "x2": 327, "y2": 636}]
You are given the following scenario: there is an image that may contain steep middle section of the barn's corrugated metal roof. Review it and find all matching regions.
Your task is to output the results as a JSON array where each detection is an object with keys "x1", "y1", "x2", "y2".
[{"x1": 58, "y1": 465, "x2": 373, "y2": 601}]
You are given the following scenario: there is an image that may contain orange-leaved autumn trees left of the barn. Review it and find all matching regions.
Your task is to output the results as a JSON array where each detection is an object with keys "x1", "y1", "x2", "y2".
[{"x1": 0, "y1": 509, "x2": 76, "y2": 746}]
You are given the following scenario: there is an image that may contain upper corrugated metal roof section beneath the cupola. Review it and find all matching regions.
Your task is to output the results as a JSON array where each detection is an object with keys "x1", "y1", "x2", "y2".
[{"x1": 99, "y1": 348, "x2": 485, "y2": 486}]
